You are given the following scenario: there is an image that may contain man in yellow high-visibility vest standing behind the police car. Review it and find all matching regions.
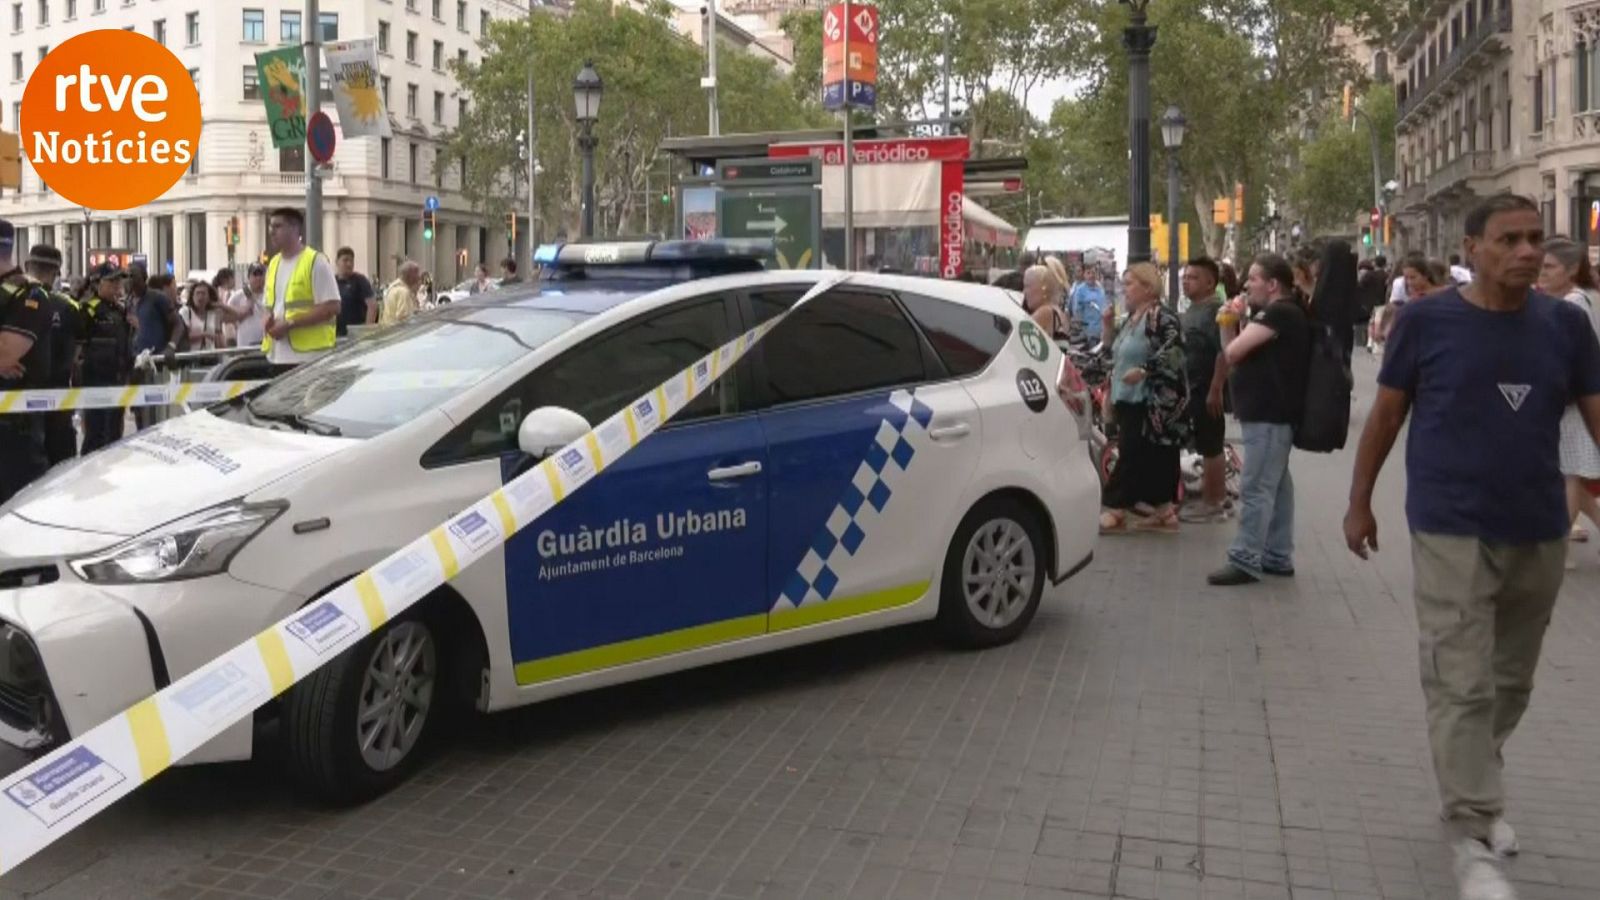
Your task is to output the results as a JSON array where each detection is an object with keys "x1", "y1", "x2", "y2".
[{"x1": 261, "y1": 207, "x2": 339, "y2": 365}]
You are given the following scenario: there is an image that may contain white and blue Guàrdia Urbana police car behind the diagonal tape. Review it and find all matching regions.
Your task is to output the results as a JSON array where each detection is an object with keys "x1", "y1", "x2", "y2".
[{"x1": 0, "y1": 242, "x2": 1099, "y2": 799}]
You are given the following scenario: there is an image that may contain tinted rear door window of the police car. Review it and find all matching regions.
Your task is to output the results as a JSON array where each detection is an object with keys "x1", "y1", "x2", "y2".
[{"x1": 750, "y1": 288, "x2": 926, "y2": 404}]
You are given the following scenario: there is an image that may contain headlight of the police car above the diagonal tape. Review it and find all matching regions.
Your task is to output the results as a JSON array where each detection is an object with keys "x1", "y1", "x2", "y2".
[{"x1": 72, "y1": 501, "x2": 288, "y2": 585}]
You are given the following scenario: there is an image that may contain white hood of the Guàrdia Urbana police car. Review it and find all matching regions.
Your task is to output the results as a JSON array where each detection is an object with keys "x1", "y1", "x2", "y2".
[{"x1": 11, "y1": 412, "x2": 347, "y2": 538}]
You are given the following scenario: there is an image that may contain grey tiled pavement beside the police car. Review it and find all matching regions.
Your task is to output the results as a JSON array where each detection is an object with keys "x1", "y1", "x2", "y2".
[{"x1": 0, "y1": 352, "x2": 1600, "y2": 900}]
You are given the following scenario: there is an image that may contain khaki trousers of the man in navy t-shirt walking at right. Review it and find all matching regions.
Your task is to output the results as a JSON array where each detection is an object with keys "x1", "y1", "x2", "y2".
[{"x1": 1411, "y1": 533, "x2": 1566, "y2": 841}]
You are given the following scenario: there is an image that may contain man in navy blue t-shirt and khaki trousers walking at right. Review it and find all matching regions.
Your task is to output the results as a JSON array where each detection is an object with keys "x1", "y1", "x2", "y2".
[{"x1": 1344, "y1": 194, "x2": 1600, "y2": 900}]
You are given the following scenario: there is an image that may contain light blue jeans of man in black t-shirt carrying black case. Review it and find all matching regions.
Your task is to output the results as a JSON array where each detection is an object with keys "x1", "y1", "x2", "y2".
[{"x1": 1227, "y1": 421, "x2": 1294, "y2": 577}]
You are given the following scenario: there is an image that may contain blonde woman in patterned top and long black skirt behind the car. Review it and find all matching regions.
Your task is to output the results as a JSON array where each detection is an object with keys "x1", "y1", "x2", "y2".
[{"x1": 1101, "y1": 263, "x2": 1189, "y2": 533}]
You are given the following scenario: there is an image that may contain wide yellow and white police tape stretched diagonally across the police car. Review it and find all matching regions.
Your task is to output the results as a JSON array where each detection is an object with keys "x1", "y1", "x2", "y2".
[{"x1": 0, "y1": 274, "x2": 846, "y2": 874}]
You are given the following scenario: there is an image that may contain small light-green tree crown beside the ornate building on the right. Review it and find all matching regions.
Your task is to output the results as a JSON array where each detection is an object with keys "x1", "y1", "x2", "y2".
[{"x1": 1290, "y1": 85, "x2": 1395, "y2": 234}]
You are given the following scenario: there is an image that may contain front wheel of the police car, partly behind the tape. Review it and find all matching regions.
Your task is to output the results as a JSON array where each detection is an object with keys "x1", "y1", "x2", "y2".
[{"x1": 285, "y1": 615, "x2": 443, "y2": 802}]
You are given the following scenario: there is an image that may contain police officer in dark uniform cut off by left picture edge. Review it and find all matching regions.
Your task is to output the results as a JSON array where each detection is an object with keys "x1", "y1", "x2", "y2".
[{"x1": 0, "y1": 219, "x2": 50, "y2": 503}]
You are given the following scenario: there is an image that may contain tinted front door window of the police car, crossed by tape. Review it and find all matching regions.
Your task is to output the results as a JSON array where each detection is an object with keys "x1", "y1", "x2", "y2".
[{"x1": 422, "y1": 298, "x2": 736, "y2": 466}]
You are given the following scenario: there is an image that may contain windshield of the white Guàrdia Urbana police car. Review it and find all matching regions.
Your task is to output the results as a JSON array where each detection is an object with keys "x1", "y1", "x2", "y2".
[{"x1": 232, "y1": 306, "x2": 586, "y2": 437}]
